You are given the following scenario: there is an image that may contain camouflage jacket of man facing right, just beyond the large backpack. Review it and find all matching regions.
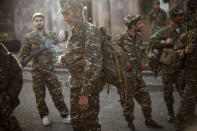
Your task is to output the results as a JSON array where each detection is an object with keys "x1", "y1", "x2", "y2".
[{"x1": 113, "y1": 32, "x2": 146, "y2": 73}]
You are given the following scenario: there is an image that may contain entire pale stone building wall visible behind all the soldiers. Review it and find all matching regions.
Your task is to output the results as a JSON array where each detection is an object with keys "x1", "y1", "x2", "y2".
[{"x1": 14, "y1": 0, "x2": 168, "y2": 41}]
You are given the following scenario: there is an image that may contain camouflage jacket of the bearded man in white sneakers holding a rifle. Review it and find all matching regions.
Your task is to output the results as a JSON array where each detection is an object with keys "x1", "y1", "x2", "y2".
[{"x1": 19, "y1": 30, "x2": 57, "y2": 72}]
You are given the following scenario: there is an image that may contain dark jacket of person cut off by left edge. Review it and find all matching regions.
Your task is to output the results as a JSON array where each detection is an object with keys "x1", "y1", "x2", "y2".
[{"x1": 0, "y1": 44, "x2": 23, "y2": 109}]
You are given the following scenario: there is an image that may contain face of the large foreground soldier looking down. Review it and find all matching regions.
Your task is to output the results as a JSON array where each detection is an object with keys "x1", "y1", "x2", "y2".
[{"x1": 62, "y1": 9, "x2": 81, "y2": 28}]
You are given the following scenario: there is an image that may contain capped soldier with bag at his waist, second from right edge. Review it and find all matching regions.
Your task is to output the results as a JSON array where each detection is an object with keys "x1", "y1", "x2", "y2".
[{"x1": 150, "y1": 7, "x2": 185, "y2": 123}]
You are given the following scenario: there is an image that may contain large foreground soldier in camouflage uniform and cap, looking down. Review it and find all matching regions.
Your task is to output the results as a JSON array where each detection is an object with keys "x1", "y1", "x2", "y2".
[{"x1": 57, "y1": 0, "x2": 104, "y2": 131}]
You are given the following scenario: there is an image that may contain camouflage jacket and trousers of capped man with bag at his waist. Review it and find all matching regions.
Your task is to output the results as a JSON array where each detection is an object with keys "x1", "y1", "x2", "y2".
[{"x1": 150, "y1": 25, "x2": 185, "y2": 104}]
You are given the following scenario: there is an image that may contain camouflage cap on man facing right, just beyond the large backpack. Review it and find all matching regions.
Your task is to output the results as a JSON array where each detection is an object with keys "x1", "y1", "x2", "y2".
[{"x1": 123, "y1": 13, "x2": 141, "y2": 26}]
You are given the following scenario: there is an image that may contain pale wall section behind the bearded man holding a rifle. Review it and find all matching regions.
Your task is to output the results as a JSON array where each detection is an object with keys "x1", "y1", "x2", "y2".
[{"x1": 14, "y1": 0, "x2": 65, "y2": 41}]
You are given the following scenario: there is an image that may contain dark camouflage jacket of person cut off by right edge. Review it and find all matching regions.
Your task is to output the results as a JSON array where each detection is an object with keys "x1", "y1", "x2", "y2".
[{"x1": 175, "y1": 29, "x2": 197, "y2": 81}]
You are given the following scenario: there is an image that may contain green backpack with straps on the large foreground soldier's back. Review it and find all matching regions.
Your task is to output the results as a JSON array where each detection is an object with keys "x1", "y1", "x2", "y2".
[{"x1": 100, "y1": 27, "x2": 128, "y2": 87}]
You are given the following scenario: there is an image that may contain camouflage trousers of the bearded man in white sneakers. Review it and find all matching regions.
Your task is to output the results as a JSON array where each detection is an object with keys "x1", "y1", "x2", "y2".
[{"x1": 32, "y1": 72, "x2": 69, "y2": 118}]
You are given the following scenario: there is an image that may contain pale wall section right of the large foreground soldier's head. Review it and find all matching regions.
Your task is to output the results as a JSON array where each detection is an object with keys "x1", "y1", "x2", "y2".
[{"x1": 92, "y1": 0, "x2": 168, "y2": 41}]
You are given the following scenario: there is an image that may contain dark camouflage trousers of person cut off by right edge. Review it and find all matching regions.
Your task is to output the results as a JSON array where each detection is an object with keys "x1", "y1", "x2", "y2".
[{"x1": 175, "y1": 80, "x2": 197, "y2": 131}]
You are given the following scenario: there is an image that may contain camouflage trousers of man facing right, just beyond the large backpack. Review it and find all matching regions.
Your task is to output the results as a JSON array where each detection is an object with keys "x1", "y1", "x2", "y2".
[{"x1": 121, "y1": 77, "x2": 152, "y2": 123}]
